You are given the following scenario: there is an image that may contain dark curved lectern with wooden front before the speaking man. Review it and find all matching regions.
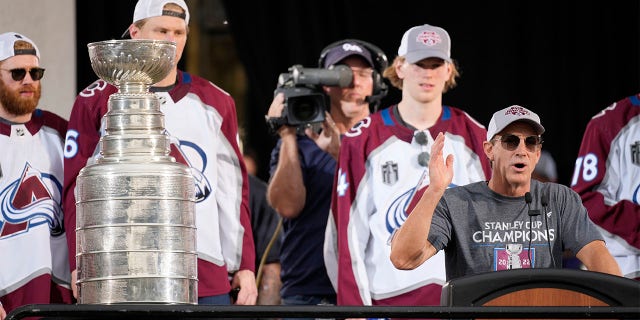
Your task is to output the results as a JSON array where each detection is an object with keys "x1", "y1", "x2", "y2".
[{"x1": 441, "y1": 269, "x2": 640, "y2": 318}]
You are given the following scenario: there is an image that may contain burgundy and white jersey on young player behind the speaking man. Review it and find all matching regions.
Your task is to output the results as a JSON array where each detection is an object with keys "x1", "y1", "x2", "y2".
[{"x1": 324, "y1": 106, "x2": 491, "y2": 305}]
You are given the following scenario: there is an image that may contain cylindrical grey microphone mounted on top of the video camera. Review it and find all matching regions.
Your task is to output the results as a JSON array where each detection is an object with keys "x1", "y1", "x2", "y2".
[{"x1": 289, "y1": 65, "x2": 353, "y2": 88}]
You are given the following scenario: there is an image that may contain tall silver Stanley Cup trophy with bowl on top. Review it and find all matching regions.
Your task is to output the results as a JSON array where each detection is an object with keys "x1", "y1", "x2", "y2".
[{"x1": 76, "y1": 40, "x2": 198, "y2": 304}]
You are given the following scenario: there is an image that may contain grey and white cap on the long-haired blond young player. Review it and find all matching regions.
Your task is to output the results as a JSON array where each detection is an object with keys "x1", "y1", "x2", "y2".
[{"x1": 398, "y1": 24, "x2": 451, "y2": 63}]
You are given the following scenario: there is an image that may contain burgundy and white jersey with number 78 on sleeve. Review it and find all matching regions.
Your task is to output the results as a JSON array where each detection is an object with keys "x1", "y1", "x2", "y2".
[{"x1": 571, "y1": 95, "x2": 640, "y2": 279}]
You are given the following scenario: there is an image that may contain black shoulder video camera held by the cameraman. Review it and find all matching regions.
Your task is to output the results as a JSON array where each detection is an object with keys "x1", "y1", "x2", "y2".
[{"x1": 274, "y1": 65, "x2": 353, "y2": 126}]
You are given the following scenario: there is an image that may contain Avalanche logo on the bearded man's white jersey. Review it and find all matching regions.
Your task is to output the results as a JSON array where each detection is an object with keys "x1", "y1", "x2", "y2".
[{"x1": 0, "y1": 163, "x2": 64, "y2": 239}]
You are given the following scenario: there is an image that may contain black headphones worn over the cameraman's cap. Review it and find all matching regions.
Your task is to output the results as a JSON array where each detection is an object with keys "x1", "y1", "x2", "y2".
[{"x1": 318, "y1": 39, "x2": 389, "y2": 111}]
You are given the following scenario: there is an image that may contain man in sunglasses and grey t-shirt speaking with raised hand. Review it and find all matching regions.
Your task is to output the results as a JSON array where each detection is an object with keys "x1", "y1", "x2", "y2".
[{"x1": 391, "y1": 105, "x2": 621, "y2": 280}]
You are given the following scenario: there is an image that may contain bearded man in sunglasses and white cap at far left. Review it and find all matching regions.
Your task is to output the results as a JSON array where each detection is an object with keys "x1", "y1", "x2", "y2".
[{"x1": 0, "y1": 32, "x2": 73, "y2": 320}]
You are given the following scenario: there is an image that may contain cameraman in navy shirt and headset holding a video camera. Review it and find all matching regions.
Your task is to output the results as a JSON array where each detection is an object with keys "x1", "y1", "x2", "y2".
[{"x1": 266, "y1": 40, "x2": 387, "y2": 316}]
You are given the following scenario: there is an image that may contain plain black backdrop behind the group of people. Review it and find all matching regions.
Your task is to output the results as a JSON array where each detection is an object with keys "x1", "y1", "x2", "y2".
[{"x1": 77, "y1": 0, "x2": 640, "y2": 184}]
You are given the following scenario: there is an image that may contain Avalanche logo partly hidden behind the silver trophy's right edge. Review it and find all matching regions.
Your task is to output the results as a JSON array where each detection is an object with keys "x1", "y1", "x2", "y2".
[{"x1": 167, "y1": 133, "x2": 213, "y2": 203}]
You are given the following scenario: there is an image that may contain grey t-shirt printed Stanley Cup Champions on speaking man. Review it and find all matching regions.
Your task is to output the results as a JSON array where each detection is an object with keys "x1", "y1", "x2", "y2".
[{"x1": 429, "y1": 180, "x2": 602, "y2": 280}]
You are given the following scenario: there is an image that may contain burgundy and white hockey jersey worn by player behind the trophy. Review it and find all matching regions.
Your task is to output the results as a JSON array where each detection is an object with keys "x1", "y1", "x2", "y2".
[{"x1": 64, "y1": 71, "x2": 255, "y2": 297}]
